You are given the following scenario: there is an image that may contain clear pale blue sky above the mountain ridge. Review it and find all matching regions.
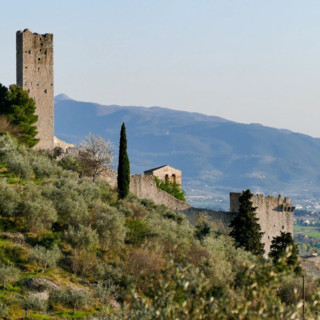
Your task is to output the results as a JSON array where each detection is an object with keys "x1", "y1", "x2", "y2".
[{"x1": 0, "y1": 0, "x2": 320, "y2": 137}]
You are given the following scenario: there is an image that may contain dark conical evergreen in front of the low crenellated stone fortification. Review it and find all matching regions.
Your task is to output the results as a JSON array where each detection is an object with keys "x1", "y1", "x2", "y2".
[{"x1": 230, "y1": 190, "x2": 264, "y2": 255}]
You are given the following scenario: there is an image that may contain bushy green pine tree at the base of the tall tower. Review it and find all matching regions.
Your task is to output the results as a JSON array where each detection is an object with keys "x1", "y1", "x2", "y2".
[{"x1": 0, "y1": 85, "x2": 39, "y2": 147}]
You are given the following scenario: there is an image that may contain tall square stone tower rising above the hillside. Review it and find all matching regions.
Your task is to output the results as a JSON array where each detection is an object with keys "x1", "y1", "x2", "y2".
[{"x1": 16, "y1": 29, "x2": 54, "y2": 149}]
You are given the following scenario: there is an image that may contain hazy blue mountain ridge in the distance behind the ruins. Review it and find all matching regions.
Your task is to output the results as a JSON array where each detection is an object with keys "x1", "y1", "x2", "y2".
[{"x1": 55, "y1": 95, "x2": 320, "y2": 208}]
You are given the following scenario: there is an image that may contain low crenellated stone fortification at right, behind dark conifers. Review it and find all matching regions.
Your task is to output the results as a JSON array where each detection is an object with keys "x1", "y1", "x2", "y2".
[{"x1": 230, "y1": 193, "x2": 294, "y2": 254}]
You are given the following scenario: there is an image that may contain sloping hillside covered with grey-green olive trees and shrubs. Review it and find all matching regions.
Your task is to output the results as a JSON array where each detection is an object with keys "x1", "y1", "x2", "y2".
[{"x1": 0, "y1": 134, "x2": 320, "y2": 320}]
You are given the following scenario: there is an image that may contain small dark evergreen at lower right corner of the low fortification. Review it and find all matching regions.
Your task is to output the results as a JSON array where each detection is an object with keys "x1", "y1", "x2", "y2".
[{"x1": 269, "y1": 232, "x2": 302, "y2": 274}]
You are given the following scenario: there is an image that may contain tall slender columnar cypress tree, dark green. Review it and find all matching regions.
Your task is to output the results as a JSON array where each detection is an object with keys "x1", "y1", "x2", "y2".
[{"x1": 118, "y1": 123, "x2": 130, "y2": 199}]
